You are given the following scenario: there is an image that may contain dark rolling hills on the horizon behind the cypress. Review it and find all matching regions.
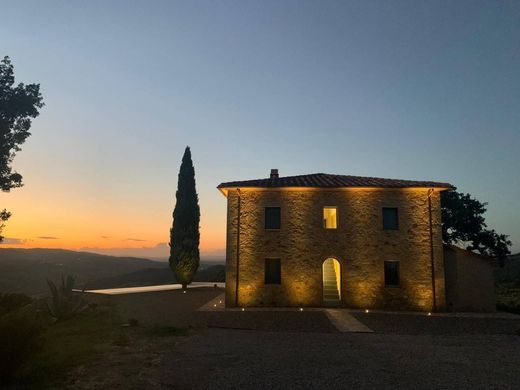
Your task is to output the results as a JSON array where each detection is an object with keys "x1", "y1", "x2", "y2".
[{"x1": 0, "y1": 248, "x2": 223, "y2": 295}]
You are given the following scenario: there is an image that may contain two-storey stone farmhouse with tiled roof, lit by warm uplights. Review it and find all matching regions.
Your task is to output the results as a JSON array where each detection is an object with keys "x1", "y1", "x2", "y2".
[{"x1": 218, "y1": 169, "x2": 494, "y2": 311}]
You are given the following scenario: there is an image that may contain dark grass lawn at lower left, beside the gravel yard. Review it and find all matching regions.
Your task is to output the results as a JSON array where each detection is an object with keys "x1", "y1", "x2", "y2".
[{"x1": 5, "y1": 303, "x2": 189, "y2": 389}]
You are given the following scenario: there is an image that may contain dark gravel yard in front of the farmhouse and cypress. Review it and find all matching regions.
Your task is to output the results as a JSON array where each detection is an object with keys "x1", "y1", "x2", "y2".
[{"x1": 92, "y1": 288, "x2": 520, "y2": 389}]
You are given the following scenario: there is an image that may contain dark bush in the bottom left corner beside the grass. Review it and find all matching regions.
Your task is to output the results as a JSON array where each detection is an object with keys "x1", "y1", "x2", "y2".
[{"x1": 0, "y1": 311, "x2": 42, "y2": 385}]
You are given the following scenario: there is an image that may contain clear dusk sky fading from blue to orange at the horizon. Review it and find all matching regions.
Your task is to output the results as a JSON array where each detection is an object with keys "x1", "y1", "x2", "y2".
[{"x1": 0, "y1": 0, "x2": 520, "y2": 257}]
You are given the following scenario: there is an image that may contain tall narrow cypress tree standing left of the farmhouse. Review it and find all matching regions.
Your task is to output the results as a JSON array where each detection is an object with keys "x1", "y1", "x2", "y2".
[{"x1": 170, "y1": 146, "x2": 200, "y2": 289}]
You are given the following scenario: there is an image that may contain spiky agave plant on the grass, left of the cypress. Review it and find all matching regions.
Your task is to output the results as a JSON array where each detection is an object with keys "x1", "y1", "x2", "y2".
[{"x1": 47, "y1": 275, "x2": 87, "y2": 321}]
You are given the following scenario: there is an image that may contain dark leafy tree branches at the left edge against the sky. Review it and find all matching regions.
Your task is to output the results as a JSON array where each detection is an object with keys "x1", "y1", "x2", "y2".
[{"x1": 0, "y1": 57, "x2": 43, "y2": 241}]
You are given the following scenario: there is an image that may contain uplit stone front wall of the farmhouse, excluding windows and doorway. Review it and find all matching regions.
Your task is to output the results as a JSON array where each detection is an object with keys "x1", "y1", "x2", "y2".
[{"x1": 226, "y1": 188, "x2": 445, "y2": 311}]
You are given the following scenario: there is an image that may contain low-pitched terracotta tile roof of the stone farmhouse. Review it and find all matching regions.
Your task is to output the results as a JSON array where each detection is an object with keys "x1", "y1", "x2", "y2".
[{"x1": 217, "y1": 173, "x2": 453, "y2": 188}]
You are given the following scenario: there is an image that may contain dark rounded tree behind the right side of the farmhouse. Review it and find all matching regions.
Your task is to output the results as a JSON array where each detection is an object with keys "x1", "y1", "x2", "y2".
[{"x1": 441, "y1": 190, "x2": 511, "y2": 264}]
